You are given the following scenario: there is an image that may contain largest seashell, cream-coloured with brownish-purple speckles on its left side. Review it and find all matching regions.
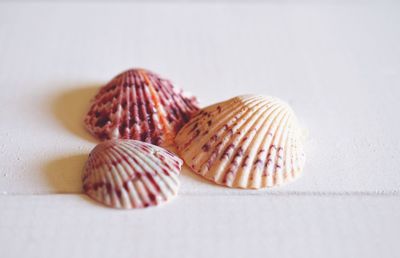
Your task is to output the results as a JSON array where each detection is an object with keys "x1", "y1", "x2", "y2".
[{"x1": 175, "y1": 95, "x2": 305, "y2": 189}]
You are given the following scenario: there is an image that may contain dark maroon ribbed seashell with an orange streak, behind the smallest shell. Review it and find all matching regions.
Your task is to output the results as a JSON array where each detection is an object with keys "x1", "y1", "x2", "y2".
[{"x1": 85, "y1": 69, "x2": 199, "y2": 146}]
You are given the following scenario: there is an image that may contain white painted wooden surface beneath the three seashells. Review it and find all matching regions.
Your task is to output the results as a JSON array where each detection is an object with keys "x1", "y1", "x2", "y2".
[{"x1": 0, "y1": 1, "x2": 400, "y2": 258}]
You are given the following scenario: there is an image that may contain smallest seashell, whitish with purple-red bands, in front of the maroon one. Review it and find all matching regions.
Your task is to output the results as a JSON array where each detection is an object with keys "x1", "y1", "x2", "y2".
[{"x1": 83, "y1": 140, "x2": 183, "y2": 209}]
